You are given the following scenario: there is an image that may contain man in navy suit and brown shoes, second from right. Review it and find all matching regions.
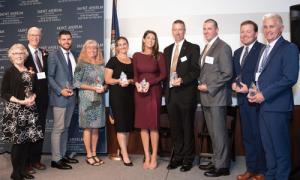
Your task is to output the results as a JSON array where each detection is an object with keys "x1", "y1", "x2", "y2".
[{"x1": 232, "y1": 20, "x2": 266, "y2": 180}]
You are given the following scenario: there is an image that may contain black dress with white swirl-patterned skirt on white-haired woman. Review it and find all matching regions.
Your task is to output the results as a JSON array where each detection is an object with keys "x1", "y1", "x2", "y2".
[{"x1": 0, "y1": 66, "x2": 43, "y2": 144}]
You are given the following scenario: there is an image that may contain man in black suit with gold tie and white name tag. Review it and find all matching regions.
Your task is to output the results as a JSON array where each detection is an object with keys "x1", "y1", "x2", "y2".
[{"x1": 164, "y1": 20, "x2": 200, "y2": 172}]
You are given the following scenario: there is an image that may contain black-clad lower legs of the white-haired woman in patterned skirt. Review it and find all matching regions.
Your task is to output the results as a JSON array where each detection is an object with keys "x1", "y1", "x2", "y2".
[{"x1": 11, "y1": 143, "x2": 29, "y2": 180}]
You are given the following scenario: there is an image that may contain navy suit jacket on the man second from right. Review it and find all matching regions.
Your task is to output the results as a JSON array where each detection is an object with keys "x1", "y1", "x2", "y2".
[{"x1": 233, "y1": 41, "x2": 264, "y2": 104}]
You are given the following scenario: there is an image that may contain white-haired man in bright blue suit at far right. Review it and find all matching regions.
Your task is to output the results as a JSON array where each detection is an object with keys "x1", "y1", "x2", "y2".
[{"x1": 248, "y1": 14, "x2": 299, "y2": 180}]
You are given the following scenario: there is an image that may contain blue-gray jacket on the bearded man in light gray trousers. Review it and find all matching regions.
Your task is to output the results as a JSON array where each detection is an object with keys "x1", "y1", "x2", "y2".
[{"x1": 48, "y1": 47, "x2": 76, "y2": 107}]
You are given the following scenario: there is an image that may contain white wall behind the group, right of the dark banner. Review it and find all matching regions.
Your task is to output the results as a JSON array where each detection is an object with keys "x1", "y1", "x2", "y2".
[{"x1": 104, "y1": 0, "x2": 300, "y2": 104}]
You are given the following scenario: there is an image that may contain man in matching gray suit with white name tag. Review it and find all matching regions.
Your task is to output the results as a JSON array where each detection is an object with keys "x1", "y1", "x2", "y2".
[{"x1": 198, "y1": 19, "x2": 232, "y2": 177}]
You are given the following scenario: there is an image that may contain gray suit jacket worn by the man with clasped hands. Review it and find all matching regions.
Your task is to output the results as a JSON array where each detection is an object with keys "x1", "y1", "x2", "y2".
[{"x1": 199, "y1": 38, "x2": 232, "y2": 107}]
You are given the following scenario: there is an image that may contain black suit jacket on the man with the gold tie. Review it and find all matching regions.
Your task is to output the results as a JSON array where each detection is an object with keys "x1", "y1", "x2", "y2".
[{"x1": 164, "y1": 40, "x2": 200, "y2": 103}]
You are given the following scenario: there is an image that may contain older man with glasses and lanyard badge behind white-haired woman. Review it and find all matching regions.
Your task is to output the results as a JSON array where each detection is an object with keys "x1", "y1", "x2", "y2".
[{"x1": 25, "y1": 27, "x2": 48, "y2": 174}]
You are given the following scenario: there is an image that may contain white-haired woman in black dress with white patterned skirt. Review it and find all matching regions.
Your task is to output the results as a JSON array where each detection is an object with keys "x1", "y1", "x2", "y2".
[{"x1": 0, "y1": 44, "x2": 43, "y2": 180}]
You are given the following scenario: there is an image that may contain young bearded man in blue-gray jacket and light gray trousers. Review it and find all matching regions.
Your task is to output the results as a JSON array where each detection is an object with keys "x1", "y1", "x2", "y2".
[{"x1": 48, "y1": 30, "x2": 78, "y2": 169}]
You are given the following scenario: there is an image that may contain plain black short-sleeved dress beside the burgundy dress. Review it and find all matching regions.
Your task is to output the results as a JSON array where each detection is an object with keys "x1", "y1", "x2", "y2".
[{"x1": 106, "y1": 57, "x2": 134, "y2": 132}]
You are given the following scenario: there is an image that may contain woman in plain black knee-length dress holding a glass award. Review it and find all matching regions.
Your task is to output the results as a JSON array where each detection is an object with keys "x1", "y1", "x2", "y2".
[{"x1": 105, "y1": 37, "x2": 134, "y2": 166}]
